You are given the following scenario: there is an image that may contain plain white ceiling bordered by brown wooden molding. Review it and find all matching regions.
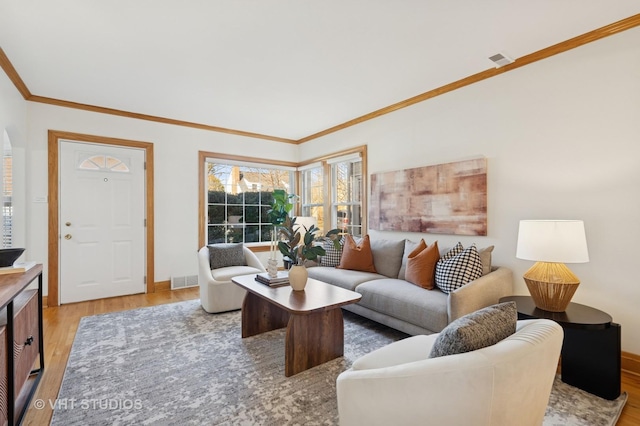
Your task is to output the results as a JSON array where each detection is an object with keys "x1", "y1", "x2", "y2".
[{"x1": 0, "y1": 0, "x2": 640, "y2": 140}]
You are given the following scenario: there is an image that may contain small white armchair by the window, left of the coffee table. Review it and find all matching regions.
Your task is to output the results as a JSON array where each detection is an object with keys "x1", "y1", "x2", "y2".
[{"x1": 198, "y1": 246, "x2": 265, "y2": 313}]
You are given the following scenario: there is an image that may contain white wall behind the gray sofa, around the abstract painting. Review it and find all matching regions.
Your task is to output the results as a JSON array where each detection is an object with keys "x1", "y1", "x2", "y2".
[{"x1": 300, "y1": 28, "x2": 640, "y2": 354}]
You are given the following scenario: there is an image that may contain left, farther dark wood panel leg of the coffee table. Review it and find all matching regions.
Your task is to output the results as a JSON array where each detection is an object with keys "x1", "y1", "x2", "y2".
[{"x1": 242, "y1": 291, "x2": 289, "y2": 337}]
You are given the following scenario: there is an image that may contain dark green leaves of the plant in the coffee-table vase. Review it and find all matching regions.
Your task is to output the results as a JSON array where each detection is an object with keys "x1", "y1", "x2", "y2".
[{"x1": 278, "y1": 216, "x2": 340, "y2": 265}]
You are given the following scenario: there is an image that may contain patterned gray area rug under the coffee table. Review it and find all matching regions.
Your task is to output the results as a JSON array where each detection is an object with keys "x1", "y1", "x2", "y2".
[{"x1": 51, "y1": 300, "x2": 626, "y2": 426}]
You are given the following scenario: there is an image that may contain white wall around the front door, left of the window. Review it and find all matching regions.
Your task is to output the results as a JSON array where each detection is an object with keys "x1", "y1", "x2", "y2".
[{"x1": 27, "y1": 102, "x2": 297, "y2": 294}]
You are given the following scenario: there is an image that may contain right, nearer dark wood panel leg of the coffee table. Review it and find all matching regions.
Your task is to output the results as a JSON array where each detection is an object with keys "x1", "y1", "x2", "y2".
[{"x1": 284, "y1": 308, "x2": 344, "y2": 377}]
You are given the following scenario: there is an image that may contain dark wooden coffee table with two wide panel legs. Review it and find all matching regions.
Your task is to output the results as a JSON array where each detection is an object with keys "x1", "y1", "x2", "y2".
[{"x1": 232, "y1": 275, "x2": 362, "y2": 377}]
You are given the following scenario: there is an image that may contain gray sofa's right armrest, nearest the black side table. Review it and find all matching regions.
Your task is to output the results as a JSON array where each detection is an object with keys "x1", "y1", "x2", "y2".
[{"x1": 447, "y1": 267, "x2": 513, "y2": 322}]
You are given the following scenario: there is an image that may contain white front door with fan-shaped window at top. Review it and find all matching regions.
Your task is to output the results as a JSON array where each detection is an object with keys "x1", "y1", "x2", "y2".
[{"x1": 59, "y1": 141, "x2": 146, "y2": 303}]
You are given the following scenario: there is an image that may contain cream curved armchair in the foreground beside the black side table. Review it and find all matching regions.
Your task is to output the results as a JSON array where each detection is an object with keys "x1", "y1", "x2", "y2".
[{"x1": 337, "y1": 320, "x2": 563, "y2": 426}]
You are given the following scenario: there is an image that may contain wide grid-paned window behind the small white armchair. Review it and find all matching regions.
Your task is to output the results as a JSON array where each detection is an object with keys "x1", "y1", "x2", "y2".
[{"x1": 205, "y1": 158, "x2": 295, "y2": 244}]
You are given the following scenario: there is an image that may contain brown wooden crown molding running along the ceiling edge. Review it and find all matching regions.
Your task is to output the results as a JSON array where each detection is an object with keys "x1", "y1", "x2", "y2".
[{"x1": 0, "y1": 14, "x2": 640, "y2": 145}]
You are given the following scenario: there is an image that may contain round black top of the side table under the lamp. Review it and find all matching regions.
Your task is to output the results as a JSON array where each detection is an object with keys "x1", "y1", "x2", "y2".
[{"x1": 500, "y1": 296, "x2": 613, "y2": 330}]
